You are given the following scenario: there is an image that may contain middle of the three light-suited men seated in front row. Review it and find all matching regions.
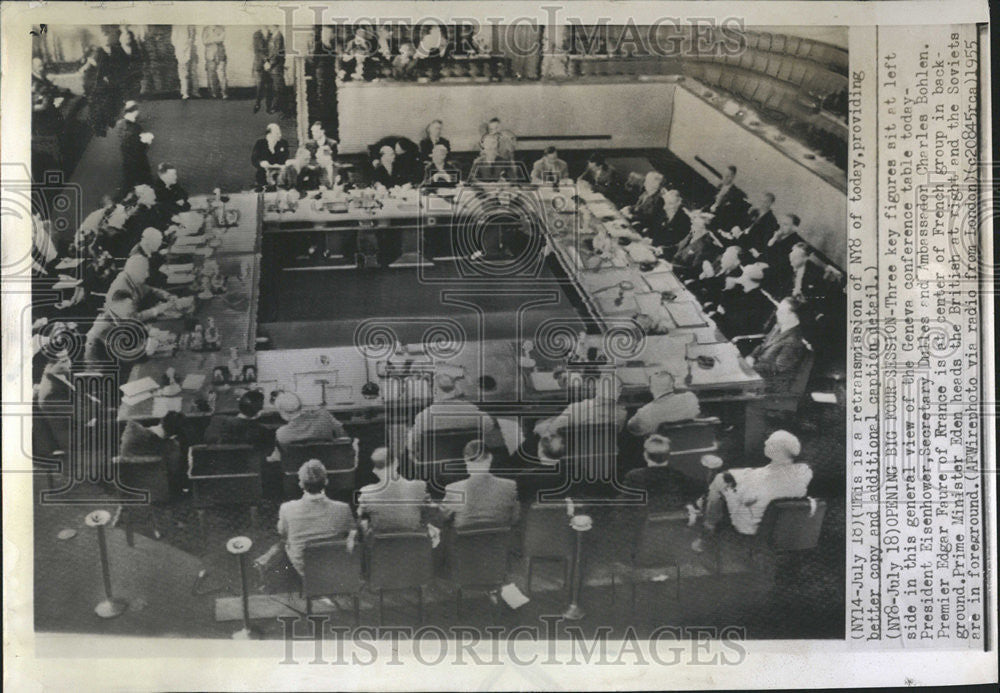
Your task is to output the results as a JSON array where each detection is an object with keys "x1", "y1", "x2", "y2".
[{"x1": 358, "y1": 448, "x2": 430, "y2": 533}]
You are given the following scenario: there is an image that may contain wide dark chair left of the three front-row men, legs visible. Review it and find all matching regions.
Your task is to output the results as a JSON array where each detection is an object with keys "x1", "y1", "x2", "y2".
[{"x1": 188, "y1": 445, "x2": 263, "y2": 542}]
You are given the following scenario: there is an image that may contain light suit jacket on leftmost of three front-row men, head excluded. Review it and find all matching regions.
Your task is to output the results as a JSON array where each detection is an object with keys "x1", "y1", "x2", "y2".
[{"x1": 278, "y1": 493, "x2": 355, "y2": 574}]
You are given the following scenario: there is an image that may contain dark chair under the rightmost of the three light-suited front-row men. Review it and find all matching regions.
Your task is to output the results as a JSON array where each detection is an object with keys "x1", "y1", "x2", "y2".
[{"x1": 448, "y1": 527, "x2": 510, "y2": 618}]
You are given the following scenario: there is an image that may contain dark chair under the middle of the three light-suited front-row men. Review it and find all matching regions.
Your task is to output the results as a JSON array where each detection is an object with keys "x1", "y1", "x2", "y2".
[{"x1": 367, "y1": 532, "x2": 434, "y2": 625}]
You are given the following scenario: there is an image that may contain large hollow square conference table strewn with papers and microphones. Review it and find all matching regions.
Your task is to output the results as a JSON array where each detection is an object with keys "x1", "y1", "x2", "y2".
[{"x1": 119, "y1": 184, "x2": 763, "y2": 438}]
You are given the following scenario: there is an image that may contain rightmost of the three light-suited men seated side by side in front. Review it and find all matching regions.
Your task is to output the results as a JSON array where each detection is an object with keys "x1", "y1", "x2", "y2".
[{"x1": 440, "y1": 440, "x2": 521, "y2": 529}]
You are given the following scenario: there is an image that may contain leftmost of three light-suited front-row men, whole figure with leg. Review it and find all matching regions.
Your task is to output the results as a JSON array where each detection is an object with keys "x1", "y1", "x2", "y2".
[{"x1": 254, "y1": 460, "x2": 357, "y2": 584}]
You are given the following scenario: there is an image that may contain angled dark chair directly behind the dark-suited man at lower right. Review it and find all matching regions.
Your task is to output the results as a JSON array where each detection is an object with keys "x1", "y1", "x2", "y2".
[{"x1": 611, "y1": 511, "x2": 697, "y2": 611}]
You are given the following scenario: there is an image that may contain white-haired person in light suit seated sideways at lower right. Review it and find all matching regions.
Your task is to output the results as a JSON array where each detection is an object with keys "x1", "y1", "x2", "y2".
[{"x1": 691, "y1": 430, "x2": 812, "y2": 552}]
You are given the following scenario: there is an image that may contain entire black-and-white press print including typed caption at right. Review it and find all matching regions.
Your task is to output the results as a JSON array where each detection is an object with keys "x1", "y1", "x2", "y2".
[{"x1": 4, "y1": 2, "x2": 996, "y2": 690}]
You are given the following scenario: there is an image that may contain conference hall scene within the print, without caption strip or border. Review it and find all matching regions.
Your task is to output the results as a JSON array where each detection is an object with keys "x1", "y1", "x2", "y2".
[{"x1": 25, "y1": 25, "x2": 848, "y2": 639}]
